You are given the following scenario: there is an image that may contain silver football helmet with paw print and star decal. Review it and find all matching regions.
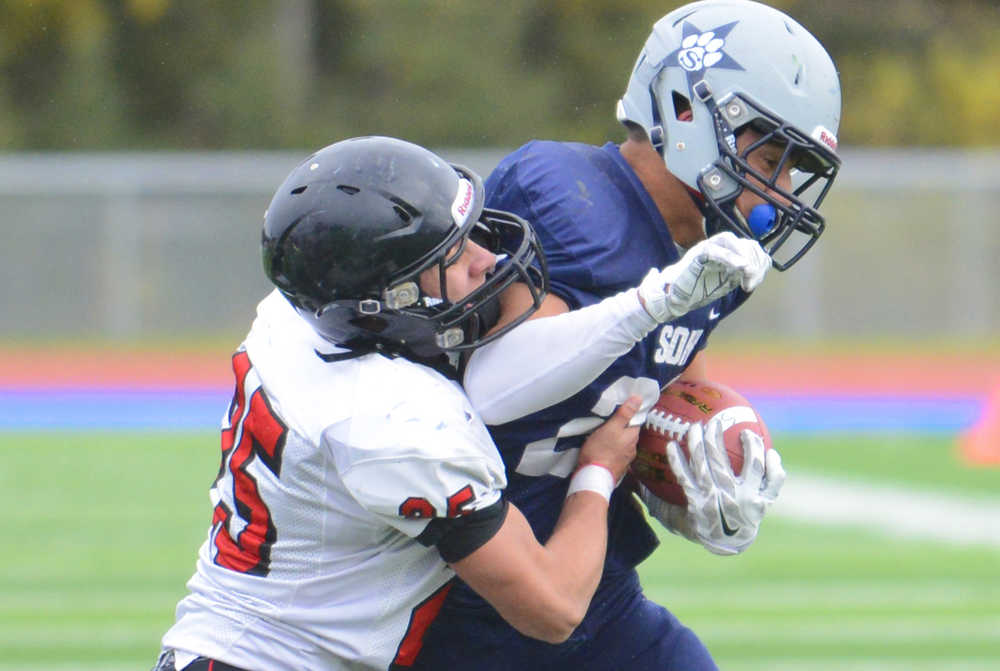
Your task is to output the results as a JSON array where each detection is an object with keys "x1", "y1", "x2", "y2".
[{"x1": 617, "y1": 0, "x2": 840, "y2": 270}]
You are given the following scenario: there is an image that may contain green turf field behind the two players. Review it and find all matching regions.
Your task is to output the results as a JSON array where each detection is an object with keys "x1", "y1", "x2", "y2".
[{"x1": 0, "y1": 432, "x2": 1000, "y2": 671}]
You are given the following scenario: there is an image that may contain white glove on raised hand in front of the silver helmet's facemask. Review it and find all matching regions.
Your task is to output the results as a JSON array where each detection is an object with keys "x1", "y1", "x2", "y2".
[{"x1": 639, "y1": 231, "x2": 771, "y2": 323}]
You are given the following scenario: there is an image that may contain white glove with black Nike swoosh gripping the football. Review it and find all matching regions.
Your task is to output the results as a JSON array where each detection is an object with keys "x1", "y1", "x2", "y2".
[{"x1": 639, "y1": 419, "x2": 785, "y2": 555}]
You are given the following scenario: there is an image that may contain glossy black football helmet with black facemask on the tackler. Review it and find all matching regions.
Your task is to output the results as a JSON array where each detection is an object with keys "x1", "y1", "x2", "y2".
[{"x1": 261, "y1": 137, "x2": 549, "y2": 359}]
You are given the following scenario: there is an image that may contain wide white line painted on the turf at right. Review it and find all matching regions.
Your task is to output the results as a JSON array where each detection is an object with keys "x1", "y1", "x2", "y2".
[{"x1": 771, "y1": 473, "x2": 1000, "y2": 547}]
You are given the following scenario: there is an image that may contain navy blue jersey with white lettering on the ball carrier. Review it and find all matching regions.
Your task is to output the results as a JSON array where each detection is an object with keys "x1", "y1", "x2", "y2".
[{"x1": 451, "y1": 141, "x2": 748, "y2": 617}]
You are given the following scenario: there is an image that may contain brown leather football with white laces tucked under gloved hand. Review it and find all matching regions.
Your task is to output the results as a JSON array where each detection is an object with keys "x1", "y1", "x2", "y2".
[{"x1": 631, "y1": 380, "x2": 771, "y2": 505}]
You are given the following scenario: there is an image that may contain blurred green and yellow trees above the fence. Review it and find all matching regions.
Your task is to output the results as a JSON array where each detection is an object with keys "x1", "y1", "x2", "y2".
[{"x1": 0, "y1": 0, "x2": 1000, "y2": 151}]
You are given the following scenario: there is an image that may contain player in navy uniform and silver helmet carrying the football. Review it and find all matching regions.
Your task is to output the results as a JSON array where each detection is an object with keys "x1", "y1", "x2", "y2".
[{"x1": 415, "y1": 0, "x2": 840, "y2": 671}]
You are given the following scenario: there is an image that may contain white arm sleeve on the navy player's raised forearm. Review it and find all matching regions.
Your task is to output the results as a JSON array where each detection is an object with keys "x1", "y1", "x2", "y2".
[{"x1": 464, "y1": 289, "x2": 656, "y2": 424}]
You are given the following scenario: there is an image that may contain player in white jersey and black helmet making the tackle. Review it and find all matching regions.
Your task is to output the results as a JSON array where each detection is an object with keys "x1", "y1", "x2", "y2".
[{"x1": 155, "y1": 137, "x2": 639, "y2": 671}]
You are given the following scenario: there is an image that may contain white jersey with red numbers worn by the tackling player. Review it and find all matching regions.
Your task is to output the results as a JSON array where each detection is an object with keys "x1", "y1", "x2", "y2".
[{"x1": 163, "y1": 292, "x2": 506, "y2": 670}]
